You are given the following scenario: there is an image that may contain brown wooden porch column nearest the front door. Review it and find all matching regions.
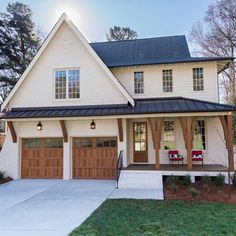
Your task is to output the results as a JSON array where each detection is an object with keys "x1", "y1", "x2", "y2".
[{"x1": 148, "y1": 117, "x2": 164, "y2": 170}]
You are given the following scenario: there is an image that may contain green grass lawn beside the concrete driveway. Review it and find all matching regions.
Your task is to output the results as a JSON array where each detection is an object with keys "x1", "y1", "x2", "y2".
[{"x1": 70, "y1": 199, "x2": 236, "y2": 236}]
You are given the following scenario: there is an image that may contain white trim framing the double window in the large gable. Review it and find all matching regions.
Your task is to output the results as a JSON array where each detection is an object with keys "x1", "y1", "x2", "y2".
[{"x1": 52, "y1": 67, "x2": 81, "y2": 102}]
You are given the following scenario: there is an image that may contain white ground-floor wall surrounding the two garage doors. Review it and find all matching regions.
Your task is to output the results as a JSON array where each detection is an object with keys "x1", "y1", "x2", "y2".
[{"x1": 0, "y1": 119, "x2": 127, "y2": 179}]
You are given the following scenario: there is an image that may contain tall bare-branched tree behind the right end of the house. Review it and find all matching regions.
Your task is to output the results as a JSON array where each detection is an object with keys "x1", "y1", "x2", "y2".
[{"x1": 190, "y1": 0, "x2": 236, "y2": 143}]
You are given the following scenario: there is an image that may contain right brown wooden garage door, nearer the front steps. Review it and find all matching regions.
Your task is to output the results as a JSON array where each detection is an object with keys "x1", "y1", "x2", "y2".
[{"x1": 72, "y1": 137, "x2": 117, "y2": 179}]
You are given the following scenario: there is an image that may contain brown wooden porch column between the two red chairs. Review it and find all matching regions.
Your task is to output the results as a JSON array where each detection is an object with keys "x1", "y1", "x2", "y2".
[{"x1": 179, "y1": 117, "x2": 196, "y2": 170}]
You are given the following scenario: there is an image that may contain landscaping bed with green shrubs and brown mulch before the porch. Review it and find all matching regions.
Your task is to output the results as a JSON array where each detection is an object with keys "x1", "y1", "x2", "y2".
[{"x1": 164, "y1": 176, "x2": 236, "y2": 203}]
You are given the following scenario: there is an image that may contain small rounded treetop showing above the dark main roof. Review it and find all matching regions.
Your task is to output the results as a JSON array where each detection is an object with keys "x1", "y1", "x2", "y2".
[{"x1": 106, "y1": 26, "x2": 138, "y2": 41}]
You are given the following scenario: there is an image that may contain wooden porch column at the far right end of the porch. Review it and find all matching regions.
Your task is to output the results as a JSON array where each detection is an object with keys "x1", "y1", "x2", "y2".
[{"x1": 219, "y1": 113, "x2": 234, "y2": 171}]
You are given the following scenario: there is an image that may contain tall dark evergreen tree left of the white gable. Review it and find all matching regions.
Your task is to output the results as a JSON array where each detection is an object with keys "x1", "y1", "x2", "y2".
[{"x1": 0, "y1": 2, "x2": 41, "y2": 101}]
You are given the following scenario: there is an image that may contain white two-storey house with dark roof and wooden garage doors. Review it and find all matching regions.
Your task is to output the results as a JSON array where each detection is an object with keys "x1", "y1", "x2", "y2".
[{"x1": 0, "y1": 14, "x2": 236, "y2": 185}]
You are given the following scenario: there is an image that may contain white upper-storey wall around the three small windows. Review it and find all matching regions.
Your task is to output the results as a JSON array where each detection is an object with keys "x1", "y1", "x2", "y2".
[{"x1": 112, "y1": 62, "x2": 218, "y2": 102}]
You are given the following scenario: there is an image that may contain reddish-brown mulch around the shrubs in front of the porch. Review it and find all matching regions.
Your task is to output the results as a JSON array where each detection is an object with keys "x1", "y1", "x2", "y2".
[{"x1": 164, "y1": 181, "x2": 236, "y2": 203}]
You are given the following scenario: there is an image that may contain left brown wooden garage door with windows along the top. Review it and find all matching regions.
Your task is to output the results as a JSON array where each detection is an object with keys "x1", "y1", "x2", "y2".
[{"x1": 21, "y1": 138, "x2": 63, "y2": 179}]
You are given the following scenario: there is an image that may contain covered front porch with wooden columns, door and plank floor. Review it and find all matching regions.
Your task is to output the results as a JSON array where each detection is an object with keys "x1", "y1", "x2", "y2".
[{"x1": 121, "y1": 112, "x2": 235, "y2": 173}]
